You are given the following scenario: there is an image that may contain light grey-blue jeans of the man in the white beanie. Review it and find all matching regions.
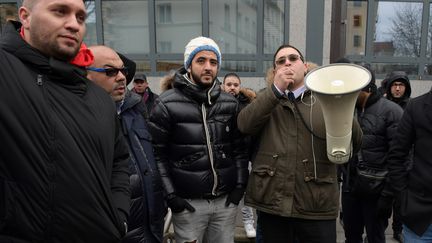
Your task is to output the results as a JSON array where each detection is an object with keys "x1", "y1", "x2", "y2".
[{"x1": 173, "y1": 195, "x2": 237, "y2": 243}]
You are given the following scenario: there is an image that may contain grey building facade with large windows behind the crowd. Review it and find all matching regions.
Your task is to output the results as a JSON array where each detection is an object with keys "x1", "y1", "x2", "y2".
[{"x1": 0, "y1": 0, "x2": 432, "y2": 95}]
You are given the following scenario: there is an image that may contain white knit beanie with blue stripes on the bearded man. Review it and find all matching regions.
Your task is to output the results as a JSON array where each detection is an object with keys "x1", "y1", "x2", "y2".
[{"x1": 184, "y1": 36, "x2": 222, "y2": 69}]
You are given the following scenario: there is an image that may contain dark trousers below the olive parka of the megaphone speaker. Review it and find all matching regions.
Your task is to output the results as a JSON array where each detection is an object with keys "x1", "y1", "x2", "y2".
[{"x1": 259, "y1": 212, "x2": 336, "y2": 243}]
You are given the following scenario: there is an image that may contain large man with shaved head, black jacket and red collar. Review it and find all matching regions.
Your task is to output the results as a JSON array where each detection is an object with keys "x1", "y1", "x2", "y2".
[{"x1": 0, "y1": 0, "x2": 130, "y2": 243}]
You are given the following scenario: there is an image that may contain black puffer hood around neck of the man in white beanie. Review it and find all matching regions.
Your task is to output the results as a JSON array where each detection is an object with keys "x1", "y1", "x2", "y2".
[{"x1": 173, "y1": 67, "x2": 221, "y2": 105}]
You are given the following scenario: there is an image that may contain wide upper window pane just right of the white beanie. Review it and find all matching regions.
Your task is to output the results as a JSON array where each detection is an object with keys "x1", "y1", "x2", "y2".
[{"x1": 209, "y1": 0, "x2": 258, "y2": 54}]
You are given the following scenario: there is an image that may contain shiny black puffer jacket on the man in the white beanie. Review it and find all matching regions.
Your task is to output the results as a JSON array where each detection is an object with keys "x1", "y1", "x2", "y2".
[{"x1": 150, "y1": 68, "x2": 248, "y2": 198}]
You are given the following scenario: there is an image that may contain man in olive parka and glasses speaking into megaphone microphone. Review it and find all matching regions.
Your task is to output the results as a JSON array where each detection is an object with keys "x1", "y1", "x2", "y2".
[{"x1": 238, "y1": 44, "x2": 361, "y2": 243}]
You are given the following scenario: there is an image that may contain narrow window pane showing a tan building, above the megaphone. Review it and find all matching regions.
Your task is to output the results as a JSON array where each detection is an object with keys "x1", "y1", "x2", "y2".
[{"x1": 345, "y1": 1, "x2": 368, "y2": 55}]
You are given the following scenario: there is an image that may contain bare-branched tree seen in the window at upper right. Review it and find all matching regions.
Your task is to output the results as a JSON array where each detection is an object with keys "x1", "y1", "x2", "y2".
[{"x1": 390, "y1": 3, "x2": 422, "y2": 57}]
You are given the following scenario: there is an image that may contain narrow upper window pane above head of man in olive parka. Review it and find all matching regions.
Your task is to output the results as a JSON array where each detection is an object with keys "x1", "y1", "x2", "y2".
[{"x1": 264, "y1": 0, "x2": 285, "y2": 54}]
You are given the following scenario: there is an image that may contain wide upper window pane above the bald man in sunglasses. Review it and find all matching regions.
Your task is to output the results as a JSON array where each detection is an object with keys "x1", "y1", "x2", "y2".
[{"x1": 102, "y1": 0, "x2": 149, "y2": 54}]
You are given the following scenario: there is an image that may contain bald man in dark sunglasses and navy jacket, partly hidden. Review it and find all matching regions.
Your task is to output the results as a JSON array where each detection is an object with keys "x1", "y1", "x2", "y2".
[{"x1": 87, "y1": 46, "x2": 167, "y2": 243}]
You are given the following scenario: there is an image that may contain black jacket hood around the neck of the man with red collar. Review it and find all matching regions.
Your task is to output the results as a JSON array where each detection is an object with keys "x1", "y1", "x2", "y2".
[{"x1": 0, "y1": 21, "x2": 90, "y2": 95}]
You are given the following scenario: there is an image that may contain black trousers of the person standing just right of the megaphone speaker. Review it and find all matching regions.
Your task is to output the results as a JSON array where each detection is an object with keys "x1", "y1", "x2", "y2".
[{"x1": 342, "y1": 192, "x2": 388, "y2": 243}]
